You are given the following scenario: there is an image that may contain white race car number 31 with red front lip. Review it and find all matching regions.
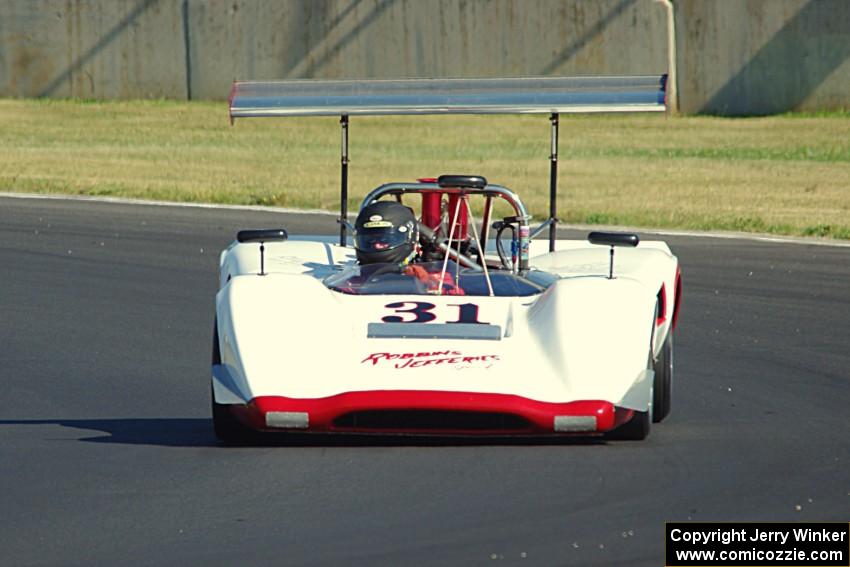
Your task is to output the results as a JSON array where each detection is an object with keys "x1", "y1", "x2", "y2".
[{"x1": 212, "y1": 74, "x2": 681, "y2": 443}]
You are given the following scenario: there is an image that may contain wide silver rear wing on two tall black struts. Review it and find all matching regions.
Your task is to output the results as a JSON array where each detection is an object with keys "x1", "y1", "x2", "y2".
[{"x1": 229, "y1": 75, "x2": 667, "y2": 250}]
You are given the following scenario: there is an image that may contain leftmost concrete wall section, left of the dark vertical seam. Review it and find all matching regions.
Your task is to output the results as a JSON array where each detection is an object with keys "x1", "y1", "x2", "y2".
[{"x1": 0, "y1": 0, "x2": 186, "y2": 98}]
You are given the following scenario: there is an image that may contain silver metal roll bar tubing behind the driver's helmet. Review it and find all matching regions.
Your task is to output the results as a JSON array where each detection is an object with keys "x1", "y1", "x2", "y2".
[{"x1": 360, "y1": 183, "x2": 531, "y2": 272}]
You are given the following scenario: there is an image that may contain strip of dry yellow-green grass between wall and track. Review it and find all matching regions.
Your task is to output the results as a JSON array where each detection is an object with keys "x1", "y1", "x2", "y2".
[{"x1": 0, "y1": 99, "x2": 850, "y2": 239}]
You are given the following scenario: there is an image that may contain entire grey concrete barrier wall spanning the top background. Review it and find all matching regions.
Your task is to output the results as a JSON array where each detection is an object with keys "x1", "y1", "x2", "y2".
[{"x1": 0, "y1": 0, "x2": 850, "y2": 114}]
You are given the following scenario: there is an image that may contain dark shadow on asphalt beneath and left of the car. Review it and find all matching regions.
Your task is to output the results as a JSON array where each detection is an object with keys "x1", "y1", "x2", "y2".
[{"x1": 0, "y1": 418, "x2": 605, "y2": 448}]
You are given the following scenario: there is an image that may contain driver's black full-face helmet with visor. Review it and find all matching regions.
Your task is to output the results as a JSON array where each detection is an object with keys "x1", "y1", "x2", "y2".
[{"x1": 354, "y1": 201, "x2": 419, "y2": 264}]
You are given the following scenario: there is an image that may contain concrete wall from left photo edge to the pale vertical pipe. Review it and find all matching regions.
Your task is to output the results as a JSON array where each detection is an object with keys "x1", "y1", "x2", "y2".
[{"x1": 0, "y1": 0, "x2": 667, "y2": 99}]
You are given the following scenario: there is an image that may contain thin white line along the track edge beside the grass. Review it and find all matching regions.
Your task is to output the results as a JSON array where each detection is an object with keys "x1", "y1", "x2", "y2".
[{"x1": 0, "y1": 191, "x2": 850, "y2": 248}]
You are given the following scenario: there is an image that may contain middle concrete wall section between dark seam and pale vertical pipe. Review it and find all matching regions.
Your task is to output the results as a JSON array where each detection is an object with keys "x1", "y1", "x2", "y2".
[{"x1": 190, "y1": 0, "x2": 667, "y2": 97}]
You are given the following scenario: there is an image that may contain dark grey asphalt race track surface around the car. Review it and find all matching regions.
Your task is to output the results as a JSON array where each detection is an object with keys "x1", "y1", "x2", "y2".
[{"x1": 0, "y1": 198, "x2": 850, "y2": 566}]
